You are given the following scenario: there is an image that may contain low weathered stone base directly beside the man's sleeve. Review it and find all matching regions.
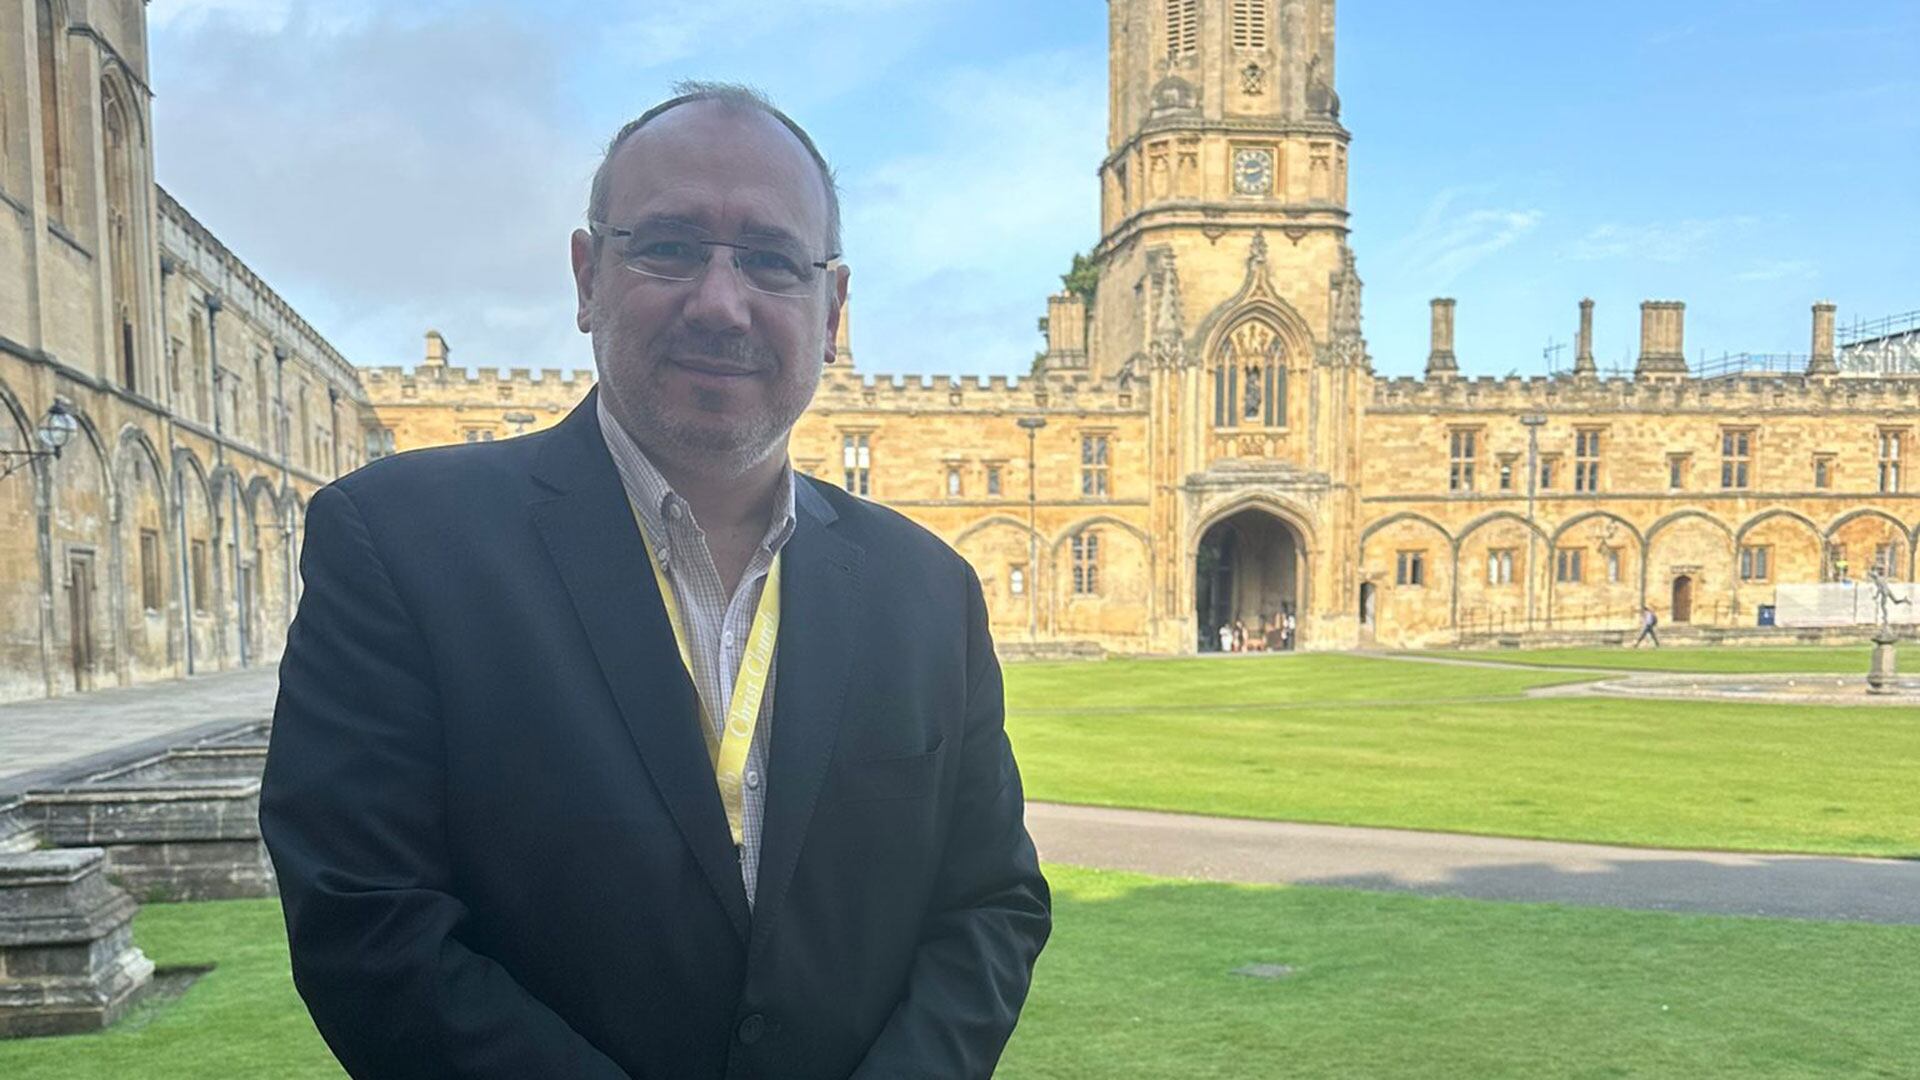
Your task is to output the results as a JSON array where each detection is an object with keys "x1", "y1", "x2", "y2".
[{"x1": 27, "y1": 772, "x2": 275, "y2": 901}]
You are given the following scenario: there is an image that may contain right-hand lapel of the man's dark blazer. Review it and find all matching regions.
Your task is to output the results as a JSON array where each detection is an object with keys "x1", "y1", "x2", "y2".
[{"x1": 747, "y1": 477, "x2": 866, "y2": 949}]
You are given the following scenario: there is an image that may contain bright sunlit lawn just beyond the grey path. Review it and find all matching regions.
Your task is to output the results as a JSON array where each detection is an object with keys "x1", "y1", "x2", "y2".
[{"x1": 1008, "y1": 653, "x2": 1920, "y2": 857}]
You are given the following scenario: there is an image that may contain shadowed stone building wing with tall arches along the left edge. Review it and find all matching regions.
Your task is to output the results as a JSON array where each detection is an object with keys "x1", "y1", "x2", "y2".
[{"x1": 0, "y1": 0, "x2": 378, "y2": 700}]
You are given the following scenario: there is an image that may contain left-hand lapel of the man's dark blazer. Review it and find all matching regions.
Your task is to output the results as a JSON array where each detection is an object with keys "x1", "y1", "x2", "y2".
[{"x1": 530, "y1": 390, "x2": 760, "y2": 940}]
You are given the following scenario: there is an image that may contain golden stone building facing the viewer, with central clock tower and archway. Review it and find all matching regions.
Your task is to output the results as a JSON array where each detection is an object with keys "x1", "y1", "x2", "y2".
[{"x1": 367, "y1": 0, "x2": 1920, "y2": 653}]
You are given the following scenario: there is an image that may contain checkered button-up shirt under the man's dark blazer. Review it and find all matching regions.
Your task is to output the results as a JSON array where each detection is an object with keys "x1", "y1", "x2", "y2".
[{"x1": 597, "y1": 390, "x2": 795, "y2": 905}]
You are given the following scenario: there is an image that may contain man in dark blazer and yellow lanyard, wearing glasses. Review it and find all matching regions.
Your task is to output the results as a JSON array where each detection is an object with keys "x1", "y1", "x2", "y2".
[{"x1": 261, "y1": 85, "x2": 1048, "y2": 1080}]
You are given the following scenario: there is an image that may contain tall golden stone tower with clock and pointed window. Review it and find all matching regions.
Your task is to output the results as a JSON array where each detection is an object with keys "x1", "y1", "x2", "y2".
[{"x1": 1089, "y1": 0, "x2": 1369, "y2": 648}]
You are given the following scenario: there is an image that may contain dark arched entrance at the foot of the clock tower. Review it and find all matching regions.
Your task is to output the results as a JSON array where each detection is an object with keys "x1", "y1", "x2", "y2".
[{"x1": 1194, "y1": 509, "x2": 1306, "y2": 651}]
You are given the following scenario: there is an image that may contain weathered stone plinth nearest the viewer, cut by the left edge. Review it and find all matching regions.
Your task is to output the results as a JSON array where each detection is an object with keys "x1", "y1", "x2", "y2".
[{"x1": 0, "y1": 847, "x2": 154, "y2": 1038}]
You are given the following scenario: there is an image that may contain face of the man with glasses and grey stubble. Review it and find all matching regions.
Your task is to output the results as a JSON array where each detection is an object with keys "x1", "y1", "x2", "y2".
[{"x1": 572, "y1": 102, "x2": 847, "y2": 475}]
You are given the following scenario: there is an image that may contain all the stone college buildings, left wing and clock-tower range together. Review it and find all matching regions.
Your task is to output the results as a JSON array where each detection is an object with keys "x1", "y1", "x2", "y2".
[{"x1": 0, "y1": 0, "x2": 1920, "y2": 698}]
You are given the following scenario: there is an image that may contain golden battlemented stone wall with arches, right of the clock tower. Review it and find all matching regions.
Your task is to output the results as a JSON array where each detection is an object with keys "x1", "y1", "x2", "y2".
[{"x1": 1361, "y1": 368, "x2": 1920, "y2": 644}]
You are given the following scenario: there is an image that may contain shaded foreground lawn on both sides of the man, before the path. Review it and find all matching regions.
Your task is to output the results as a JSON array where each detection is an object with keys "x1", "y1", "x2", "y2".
[{"x1": 0, "y1": 867, "x2": 1920, "y2": 1080}]
